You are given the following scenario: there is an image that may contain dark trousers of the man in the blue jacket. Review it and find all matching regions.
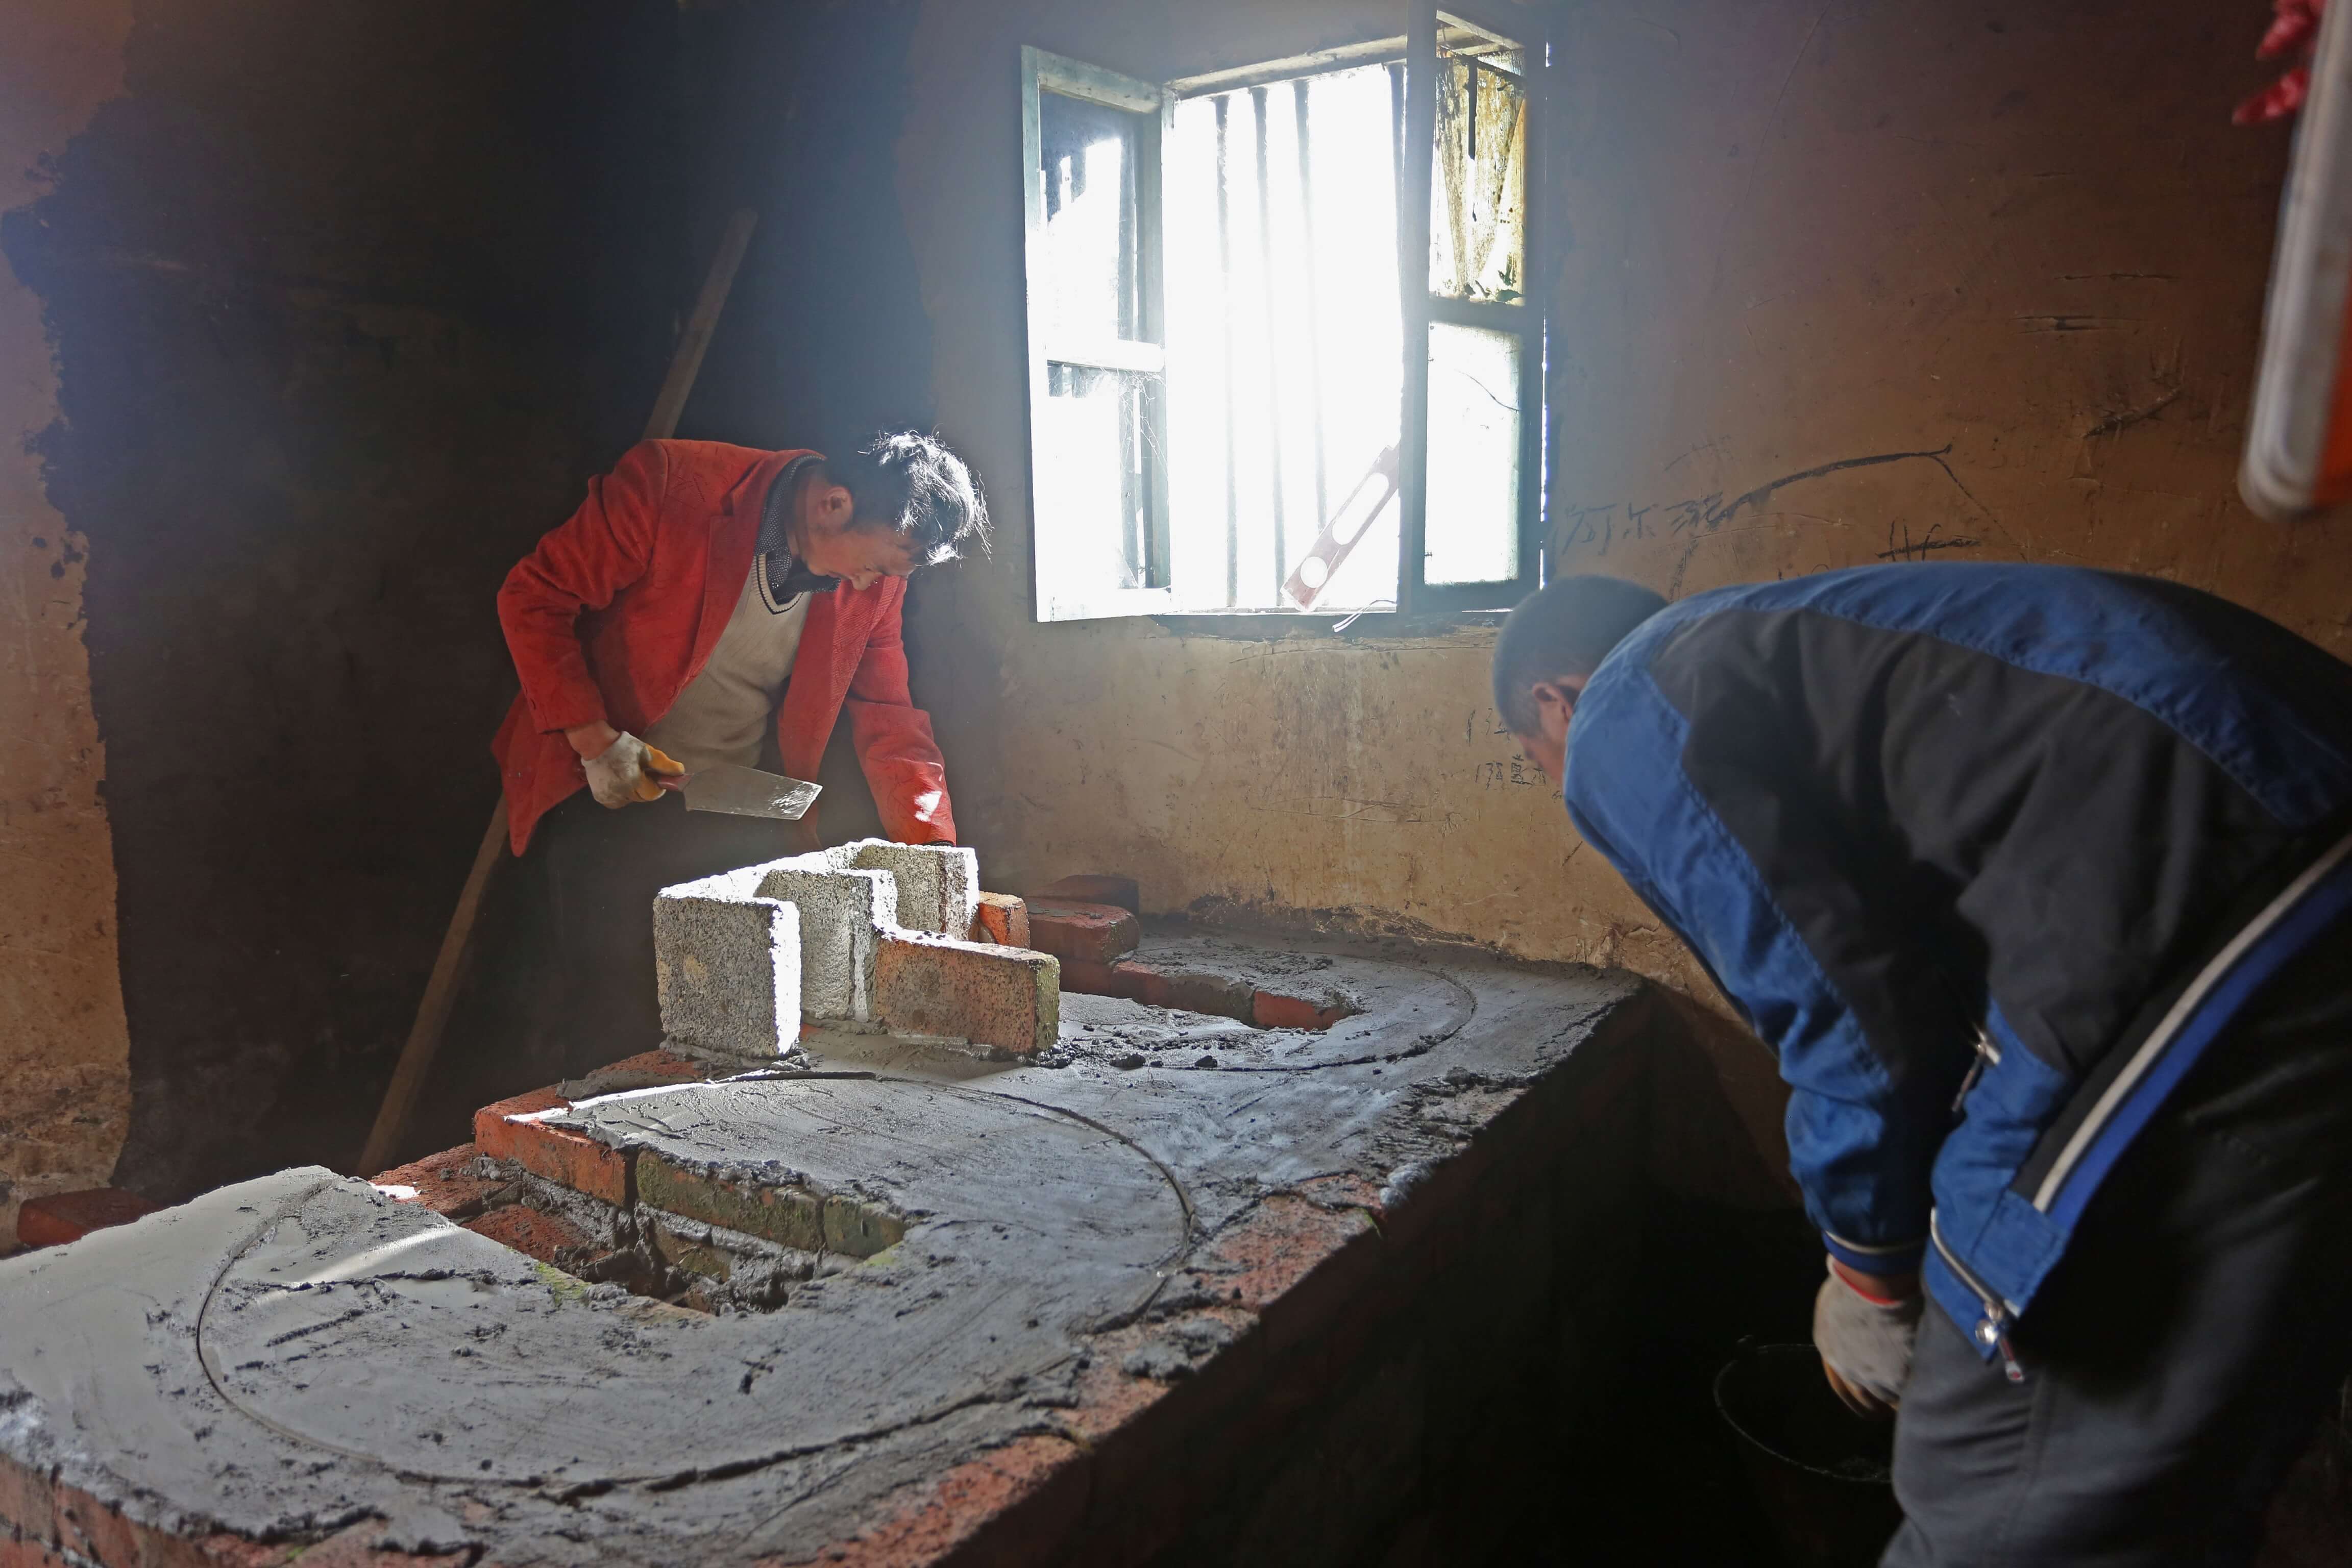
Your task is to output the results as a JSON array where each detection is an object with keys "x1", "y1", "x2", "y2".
[{"x1": 1881, "y1": 921, "x2": 2352, "y2": 1568}]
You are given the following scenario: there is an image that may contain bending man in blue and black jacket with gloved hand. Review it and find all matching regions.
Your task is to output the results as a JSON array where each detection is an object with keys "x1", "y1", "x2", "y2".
[{"x1": 1493, "y1": 564, "x2": 2352, "y2": 1568}]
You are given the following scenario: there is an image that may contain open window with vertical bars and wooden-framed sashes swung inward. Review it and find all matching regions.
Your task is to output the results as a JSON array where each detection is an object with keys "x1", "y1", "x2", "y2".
[{"x1": 1023, "y1": 9, "x2": 1545, "y2": 621}]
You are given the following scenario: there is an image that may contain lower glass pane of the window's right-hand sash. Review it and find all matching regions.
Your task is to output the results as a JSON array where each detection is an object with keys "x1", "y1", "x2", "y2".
[{"x1": 1423, "y1": 322, "x2": 1522, "y2": 583}]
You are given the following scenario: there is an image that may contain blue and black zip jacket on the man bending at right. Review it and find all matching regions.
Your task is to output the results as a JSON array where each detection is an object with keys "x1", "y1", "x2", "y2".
[{"x1": 1564, "y1": 564, "x2": 2352, "y2": 1366}]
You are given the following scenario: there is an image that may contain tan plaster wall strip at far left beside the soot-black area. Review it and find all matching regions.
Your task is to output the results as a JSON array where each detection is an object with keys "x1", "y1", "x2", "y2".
[{"x1": 0, "y1": 0, "x2": 132, "y2": 1251}]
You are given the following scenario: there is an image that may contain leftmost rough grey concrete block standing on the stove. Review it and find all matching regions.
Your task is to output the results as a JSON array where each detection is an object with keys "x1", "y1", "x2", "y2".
[{"x1": 654, "y1": 872, "x2": 802, "y2": 1060}]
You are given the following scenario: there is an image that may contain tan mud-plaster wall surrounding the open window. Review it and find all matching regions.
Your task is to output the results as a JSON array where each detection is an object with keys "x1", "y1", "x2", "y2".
[{"x1": 898, "y1": 0, "x2": 2352, "y2": 1175}]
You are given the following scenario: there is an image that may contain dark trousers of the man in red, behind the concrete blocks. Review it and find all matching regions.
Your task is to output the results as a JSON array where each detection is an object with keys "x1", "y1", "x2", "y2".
[{"x1": 529, "y1": 790, "x2": 814, "y2": 1076}]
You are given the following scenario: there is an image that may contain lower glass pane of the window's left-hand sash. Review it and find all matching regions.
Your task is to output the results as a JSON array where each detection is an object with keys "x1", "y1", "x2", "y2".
[{"x1": 1033, "y1": 364, "x2": 1153, "y2": 606}]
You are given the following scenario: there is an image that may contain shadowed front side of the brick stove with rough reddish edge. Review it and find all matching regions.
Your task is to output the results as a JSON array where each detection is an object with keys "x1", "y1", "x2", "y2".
[{"x1": 776, "y1": 985, "x2": 1679, "y2": 1568}]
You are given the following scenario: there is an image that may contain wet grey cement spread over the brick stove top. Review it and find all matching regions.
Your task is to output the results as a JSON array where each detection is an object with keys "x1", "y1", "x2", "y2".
[{"x1": 0, "y1": 936, "x2": 1637, "y2": 1565}]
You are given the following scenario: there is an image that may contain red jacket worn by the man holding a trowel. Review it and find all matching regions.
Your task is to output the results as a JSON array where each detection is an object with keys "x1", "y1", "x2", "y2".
[{"x1": 492, "y1": 442, "x2": 955, "y2": 855}]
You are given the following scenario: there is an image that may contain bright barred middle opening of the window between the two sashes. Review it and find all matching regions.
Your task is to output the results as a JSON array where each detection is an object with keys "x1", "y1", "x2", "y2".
[{"x1": 1167, "y1": 66, "x2": 1404, "y2": 611}]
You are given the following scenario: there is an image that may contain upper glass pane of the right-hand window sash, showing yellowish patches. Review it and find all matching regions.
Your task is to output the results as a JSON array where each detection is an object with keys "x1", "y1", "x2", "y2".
[{"x1": 1430, "y1": 26, "x2": 1527, "y2": 306}]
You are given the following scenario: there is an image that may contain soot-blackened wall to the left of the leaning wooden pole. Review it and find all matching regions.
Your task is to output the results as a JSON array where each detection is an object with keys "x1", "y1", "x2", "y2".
[{"x1": 0, "y1": 0, "x2": 699, "y2": 1196}]
